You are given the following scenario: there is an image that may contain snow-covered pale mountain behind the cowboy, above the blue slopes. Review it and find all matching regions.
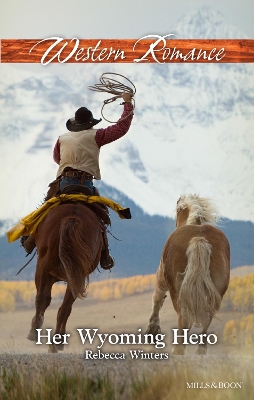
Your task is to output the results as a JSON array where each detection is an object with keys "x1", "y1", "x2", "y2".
[{"x1": 0, "y1": 8, "x2": 254, "y2": 236}]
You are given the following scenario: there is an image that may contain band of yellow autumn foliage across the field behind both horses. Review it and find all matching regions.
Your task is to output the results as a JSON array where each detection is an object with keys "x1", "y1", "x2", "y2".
[{"x1": 0, "y1": 274, "x2": 254, "y2": 314}]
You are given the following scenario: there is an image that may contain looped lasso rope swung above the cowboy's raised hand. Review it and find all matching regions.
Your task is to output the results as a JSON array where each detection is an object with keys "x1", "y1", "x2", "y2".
[{"x1": 88, "y1": 72, "x2": 136, "y2": 124}]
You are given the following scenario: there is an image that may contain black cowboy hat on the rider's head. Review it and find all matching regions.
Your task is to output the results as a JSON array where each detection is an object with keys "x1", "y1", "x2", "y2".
[{"x1": 66, "y1": 107, "x2": 101, "y2": 132}]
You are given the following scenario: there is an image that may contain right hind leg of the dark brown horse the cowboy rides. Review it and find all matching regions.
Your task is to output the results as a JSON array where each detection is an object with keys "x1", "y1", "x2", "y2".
[{"x1": 49, "y1": 285, "x2": 75, "y2": 353}]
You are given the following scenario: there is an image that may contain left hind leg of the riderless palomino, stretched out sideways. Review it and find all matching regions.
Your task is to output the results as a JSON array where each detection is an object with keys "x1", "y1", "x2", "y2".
[{"x1": 146, "y1": 263, "x2": 168, "y2": 335}]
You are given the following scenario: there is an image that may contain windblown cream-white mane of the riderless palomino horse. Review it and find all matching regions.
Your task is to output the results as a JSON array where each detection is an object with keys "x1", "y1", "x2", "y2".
[{"x1": 176, "y1": 194, "x2": 220, "y2": 225}]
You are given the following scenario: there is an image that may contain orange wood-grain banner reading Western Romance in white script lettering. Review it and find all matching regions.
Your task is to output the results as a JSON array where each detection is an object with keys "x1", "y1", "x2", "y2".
[{"x1": 1, "y1": 34, "x2": 254, "y2": 65}]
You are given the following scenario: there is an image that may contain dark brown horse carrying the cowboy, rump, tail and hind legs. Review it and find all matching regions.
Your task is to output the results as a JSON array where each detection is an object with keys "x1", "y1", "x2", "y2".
[{"x1": 27, "y1": 203, "x2": 103, "y2": 352}]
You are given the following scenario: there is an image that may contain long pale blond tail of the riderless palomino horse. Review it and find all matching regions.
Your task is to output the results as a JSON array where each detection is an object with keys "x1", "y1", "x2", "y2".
[{"x1": 178, "y1": 237, "x2": 222, "y2": 328}]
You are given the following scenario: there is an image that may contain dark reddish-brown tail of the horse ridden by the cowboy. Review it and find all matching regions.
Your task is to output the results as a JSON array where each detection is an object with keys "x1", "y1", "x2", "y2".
[{"x1": 59, "y1": 217, "x2": 92, "y2": 299}]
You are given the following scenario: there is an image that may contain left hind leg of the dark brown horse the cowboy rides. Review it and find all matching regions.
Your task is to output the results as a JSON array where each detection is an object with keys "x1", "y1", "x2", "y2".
[{"x1": 27, "y1": 271, "x2": 57, "y2": 342}]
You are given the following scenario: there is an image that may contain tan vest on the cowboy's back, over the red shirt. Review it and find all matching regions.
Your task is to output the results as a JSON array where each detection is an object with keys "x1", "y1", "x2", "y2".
[{"x1": 57, "y1": 129, "x2": 101, "y2": 179}]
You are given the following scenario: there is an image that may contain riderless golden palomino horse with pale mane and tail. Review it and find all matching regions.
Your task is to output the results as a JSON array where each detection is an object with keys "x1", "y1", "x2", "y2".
[{"x1": 146, "y1": 195, "x2": 230, "y2": 354}]
